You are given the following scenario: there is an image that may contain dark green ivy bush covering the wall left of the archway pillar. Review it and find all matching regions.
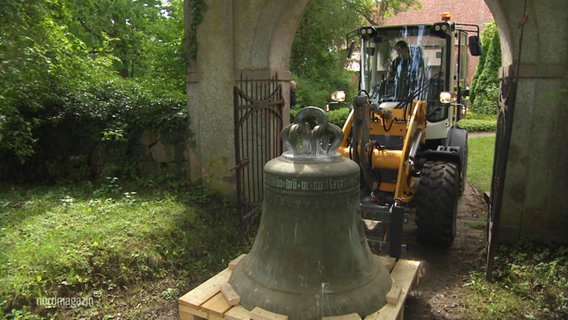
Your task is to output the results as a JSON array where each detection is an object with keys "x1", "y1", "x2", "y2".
[{"x1": 0, "y1": 79, "x2": 189, "y2": 182}]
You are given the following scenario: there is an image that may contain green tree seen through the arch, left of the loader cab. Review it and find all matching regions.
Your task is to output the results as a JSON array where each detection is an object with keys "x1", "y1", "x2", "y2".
[{"x1": 290, "y1": 0, "x2": 419, "y2": 106}]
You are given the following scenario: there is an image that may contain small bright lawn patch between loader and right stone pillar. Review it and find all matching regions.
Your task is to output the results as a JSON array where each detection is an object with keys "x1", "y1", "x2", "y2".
[{"x1": 467, "y1": 136, "x2": 495, "y2": 192}]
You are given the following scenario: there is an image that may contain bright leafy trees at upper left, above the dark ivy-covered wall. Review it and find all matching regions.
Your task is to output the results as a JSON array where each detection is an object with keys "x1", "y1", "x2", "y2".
[{"x1": 0, "y1": 0, "x2": 185, "y2": 162}]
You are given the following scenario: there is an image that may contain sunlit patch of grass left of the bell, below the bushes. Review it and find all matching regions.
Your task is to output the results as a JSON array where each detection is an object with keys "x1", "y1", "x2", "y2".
[{"x1": 0, "y1": 180, "x2": 244, "y2": 319}]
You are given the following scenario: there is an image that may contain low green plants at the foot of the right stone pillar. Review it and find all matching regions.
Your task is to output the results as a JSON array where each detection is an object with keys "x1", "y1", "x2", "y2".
[{"x1": 462, "y1": 240, "x2": 568, "y2": 320}]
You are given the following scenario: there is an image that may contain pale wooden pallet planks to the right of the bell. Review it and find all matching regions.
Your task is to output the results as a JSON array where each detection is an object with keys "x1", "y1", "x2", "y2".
[{"x1": 365, "y1": 260, "x2": 420, "y2": 320}]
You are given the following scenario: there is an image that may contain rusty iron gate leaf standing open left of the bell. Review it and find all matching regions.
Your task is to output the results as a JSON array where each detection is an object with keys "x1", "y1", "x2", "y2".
[{"x1": 233, "y1": 76, "x2": 284, "y2": 242}]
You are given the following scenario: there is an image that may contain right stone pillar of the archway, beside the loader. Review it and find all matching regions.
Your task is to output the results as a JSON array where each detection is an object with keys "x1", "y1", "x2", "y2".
[{"x1": 487, "y1": 0, "x2": 568, "y2": 243}]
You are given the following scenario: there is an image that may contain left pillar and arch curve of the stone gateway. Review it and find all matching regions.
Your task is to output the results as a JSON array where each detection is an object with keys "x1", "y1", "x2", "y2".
[{"x1": 185, "y1": 0, "x2": 310, "y2": 194}]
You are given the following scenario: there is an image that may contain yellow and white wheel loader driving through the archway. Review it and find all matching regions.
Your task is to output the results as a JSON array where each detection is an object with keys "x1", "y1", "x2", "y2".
[{"x1": 337, "y1": 15, "x2": 481, "y2": 257}]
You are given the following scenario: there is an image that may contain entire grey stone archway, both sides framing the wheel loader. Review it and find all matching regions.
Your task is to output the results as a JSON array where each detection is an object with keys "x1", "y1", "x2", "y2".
[{"x1": 185, "y1": 0, "x2": 568, "y2": 243}]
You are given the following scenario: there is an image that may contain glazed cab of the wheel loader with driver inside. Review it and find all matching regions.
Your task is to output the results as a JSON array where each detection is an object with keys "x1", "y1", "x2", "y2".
[{"x1": 351, "y1": 21, "x2": 481, "y2": 140}]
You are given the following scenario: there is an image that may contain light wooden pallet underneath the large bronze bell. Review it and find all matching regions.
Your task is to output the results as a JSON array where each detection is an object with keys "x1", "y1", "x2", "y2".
[{"x1": 178, "y1": 254, "x2": 421, "y2": 320}]
